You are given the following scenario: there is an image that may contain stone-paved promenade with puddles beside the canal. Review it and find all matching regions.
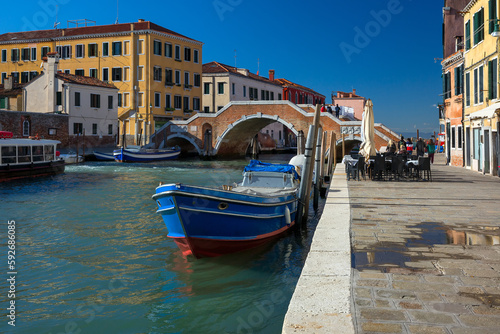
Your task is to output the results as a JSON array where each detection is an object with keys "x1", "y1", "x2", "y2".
[{"x1": 348, "y1": 155, "x2": 500, "y2": 334}]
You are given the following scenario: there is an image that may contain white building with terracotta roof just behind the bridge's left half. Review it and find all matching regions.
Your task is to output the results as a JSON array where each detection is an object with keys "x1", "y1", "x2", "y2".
[{"x1": 202, "y1": 61, "x2": 283, "y2": 113}]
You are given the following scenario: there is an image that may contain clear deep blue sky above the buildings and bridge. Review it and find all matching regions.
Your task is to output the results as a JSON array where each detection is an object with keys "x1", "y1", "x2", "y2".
[{"x1": 0, "y1": 0, "x2": 443, "y2": 136}]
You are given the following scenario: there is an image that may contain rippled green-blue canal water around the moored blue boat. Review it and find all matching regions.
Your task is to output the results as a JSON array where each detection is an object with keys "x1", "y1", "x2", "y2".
[{"x1": 0, "y1": 156, "x2": 322, "y2": 334}]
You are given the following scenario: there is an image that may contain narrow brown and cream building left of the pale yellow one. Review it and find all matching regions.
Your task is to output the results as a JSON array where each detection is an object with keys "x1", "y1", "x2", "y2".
[{"x1": 439, "y1": 0, "x2": 466, "y2": 167}]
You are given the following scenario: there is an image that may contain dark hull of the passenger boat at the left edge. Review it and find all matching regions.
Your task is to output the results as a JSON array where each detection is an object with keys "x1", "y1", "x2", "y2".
[{"x1": 0, "y1": 159, "x2": 65, "y2": 181}]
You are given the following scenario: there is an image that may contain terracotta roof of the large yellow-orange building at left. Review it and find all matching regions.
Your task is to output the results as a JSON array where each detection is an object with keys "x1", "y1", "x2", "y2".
[{"x1": 0, "y1": 21, "x2": 201, "y2": 43}]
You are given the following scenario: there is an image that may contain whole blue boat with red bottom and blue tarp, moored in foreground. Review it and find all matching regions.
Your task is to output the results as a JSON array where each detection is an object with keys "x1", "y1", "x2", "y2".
[{"x1": 153, "y1": 160, "x2": 299, "y2": 258}]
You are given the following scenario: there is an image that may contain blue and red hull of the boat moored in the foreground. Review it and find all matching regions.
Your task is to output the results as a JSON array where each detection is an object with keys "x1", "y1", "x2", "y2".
[{"x1": 153, "y1": 184, "x2": 297, "y2": 258}]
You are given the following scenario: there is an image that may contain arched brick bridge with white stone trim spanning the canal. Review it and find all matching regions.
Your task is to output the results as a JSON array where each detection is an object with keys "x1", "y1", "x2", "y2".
[{"x1": 151, "y1": 101, "x2": 399, "y2": 156}]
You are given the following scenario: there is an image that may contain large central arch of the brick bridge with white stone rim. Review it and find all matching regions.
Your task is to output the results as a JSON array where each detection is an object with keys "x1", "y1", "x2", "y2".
[{"x1": 214, "y1": 112, "x2": 298, "y2": 154}]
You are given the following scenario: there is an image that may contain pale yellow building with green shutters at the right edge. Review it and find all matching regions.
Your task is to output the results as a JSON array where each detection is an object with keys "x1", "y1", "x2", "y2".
[{"x1": 462, "y1": 0, "x2": 500, "y2": 175}]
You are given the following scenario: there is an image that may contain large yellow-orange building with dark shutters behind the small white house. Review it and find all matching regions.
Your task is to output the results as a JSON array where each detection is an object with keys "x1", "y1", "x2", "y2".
[{"x1": 0, "y1": 20, "x2": 203, "y2": 142}]
